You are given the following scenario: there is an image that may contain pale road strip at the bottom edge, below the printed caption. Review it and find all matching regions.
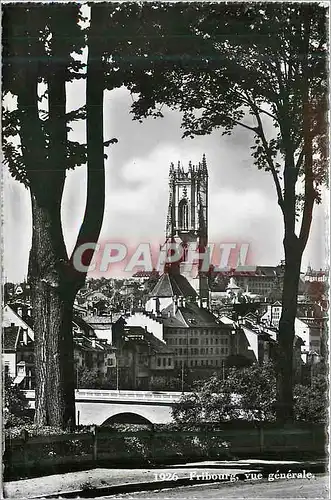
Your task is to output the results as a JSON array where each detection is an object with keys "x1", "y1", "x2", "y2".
[{"x1": 109, "y1": 475, "x2": 329, "y2": 500}]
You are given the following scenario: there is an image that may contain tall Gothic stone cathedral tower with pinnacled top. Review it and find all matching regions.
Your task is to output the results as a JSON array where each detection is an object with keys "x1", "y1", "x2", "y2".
[{"x1": 166, "y1": 155, "x2": 208, "y2": 299}]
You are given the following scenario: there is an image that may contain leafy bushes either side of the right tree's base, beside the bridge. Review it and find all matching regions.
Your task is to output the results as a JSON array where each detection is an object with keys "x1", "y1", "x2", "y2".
[{"x1": 173, "y1": 363, "x2": 327, "y2": 426}]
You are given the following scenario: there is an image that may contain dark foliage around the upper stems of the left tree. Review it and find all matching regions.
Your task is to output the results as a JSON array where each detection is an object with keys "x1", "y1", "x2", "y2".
[{"x1": 2, "y1": 4, "x2": 87, "y2": 186}]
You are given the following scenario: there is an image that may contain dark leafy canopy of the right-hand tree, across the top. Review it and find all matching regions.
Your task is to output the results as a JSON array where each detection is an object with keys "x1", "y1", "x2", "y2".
[{"x1": 115, "y1": 3, "x2": 327, "y2": 221}]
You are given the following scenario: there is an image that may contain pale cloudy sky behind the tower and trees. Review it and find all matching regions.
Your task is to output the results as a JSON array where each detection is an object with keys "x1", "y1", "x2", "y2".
[{"x1": 3, "y1": 82, "x2": 327, "y2": 282}]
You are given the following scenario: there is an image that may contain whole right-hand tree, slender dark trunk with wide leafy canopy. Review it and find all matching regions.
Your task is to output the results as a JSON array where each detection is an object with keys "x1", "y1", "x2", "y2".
[{"x1": 112, "y1": 2, "x2": 328, "y2": 420}]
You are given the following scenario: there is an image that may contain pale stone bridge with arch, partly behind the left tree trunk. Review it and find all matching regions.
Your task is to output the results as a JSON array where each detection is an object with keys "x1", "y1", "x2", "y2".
[{"x1": 23, "y1": 389, "x2": 187, "y2": 425}]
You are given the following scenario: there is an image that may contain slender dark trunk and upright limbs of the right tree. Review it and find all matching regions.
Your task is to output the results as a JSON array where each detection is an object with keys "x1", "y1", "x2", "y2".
[{"x1": 277, "y1": 8, "x2": 315, "y2": 422}]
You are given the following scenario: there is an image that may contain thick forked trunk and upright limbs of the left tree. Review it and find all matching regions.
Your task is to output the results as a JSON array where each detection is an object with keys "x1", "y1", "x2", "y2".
[{"x1": 18, "y1": 6, "x2": 107, "y2": 428}]
